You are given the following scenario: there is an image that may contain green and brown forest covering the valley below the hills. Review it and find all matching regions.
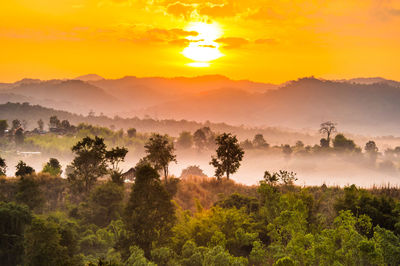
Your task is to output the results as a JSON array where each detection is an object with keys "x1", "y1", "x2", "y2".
[{"x1": 0, "y1": 116, "x2": 400, "y2": 266}]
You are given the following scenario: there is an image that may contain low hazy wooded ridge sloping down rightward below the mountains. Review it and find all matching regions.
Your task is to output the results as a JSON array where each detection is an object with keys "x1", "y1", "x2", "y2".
[{"x1": 0, "y1": 102, "x2": 319, "y2": 143}]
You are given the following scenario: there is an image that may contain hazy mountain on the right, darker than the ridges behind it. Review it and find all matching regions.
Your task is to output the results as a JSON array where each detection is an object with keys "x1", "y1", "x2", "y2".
[{"x1": 144, "y1": 78, "x2": 400, "y2": 135}]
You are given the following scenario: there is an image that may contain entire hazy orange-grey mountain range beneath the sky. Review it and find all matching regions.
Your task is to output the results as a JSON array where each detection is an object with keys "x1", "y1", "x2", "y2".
[{"x1": 0, "y1": 74, "x2": 400, "y2": 135}]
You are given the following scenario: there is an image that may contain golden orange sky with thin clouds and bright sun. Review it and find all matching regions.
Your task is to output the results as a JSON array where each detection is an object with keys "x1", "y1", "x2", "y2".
[{"x1": 0, "y1": 0, "x2": 400, "y2": 83}]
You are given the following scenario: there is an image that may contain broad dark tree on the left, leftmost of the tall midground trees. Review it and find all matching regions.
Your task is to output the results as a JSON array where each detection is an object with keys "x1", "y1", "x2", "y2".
[{"x1": 68, "y1": 136, "x2": 107, "y2": 192}]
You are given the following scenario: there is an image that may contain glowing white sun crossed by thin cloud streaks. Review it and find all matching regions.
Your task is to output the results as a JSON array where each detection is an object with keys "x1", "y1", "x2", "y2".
[{"x1": 182, "y1": 22, "x2": 223, "y2": 67}]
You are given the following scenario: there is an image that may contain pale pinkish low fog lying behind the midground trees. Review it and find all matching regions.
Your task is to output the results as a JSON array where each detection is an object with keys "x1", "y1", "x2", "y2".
[{"x1": 6, "y1": 150, "x2": 400, "y2": 187}]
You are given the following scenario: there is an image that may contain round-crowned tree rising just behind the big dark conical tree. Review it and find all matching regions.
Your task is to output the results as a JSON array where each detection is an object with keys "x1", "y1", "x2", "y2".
[{"x1": 144, "y1": 134, "x2": 177, "y2": 182}]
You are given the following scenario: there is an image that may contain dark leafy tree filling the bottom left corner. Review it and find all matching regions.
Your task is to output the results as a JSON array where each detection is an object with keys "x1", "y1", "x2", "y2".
[{"x1": 0, "y1": 202, "x2": 32, "y2": 265}]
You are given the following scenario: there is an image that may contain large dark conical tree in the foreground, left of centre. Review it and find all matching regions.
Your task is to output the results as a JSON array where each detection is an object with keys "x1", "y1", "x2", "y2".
[{"x1": 122, "y1": 164, "x2": 175, "y2": 258}]
